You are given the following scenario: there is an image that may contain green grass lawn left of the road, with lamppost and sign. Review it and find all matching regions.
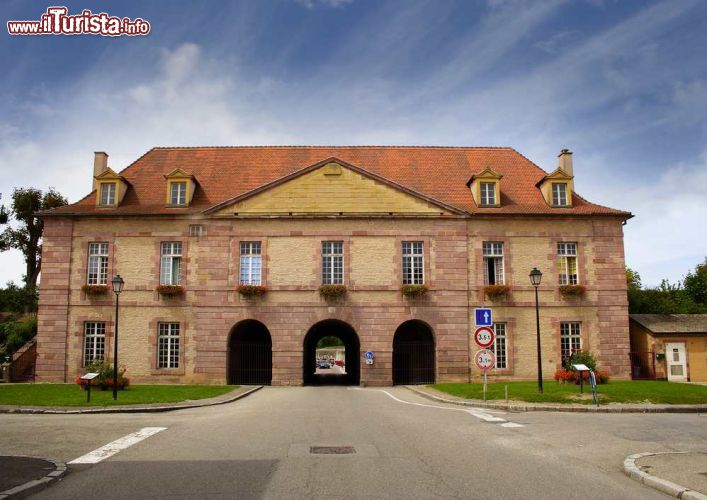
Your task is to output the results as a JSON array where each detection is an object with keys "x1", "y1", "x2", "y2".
[{"x1": 0, "y1": 384, "x2": 237, "y2": 406}]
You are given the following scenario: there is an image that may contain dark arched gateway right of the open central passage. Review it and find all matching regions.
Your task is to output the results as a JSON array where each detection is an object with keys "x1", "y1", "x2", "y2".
[{"x1": 393, "y1": 319, "x2": 435, "y2": 385}]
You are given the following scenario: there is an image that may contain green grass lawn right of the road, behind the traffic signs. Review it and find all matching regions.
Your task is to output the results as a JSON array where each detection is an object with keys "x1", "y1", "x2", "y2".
[{"x1": 430, "y1": 380, "x2": 707, "y2": 404}]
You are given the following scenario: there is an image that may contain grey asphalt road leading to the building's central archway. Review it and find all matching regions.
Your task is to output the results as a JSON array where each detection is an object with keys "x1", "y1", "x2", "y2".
[{"x1": 0, "y1": 387, "x2": 707, "y2": 499}]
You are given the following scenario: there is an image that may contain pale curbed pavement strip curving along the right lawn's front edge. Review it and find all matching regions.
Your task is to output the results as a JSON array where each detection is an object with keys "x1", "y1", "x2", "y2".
[{"x1": 405, "y1": 385, "x2": 707, "y2": 413}]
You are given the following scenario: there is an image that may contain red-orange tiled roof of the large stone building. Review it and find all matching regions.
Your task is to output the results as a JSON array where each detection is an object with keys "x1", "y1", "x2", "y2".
[{"x1": 45, "y1": 146, "x2": 631, "y2": 218}]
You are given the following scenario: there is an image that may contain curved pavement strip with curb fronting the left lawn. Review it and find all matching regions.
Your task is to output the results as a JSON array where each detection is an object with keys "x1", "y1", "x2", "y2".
[{"x1": 0, "y1": 385, "x2": 263, "y2": 415}]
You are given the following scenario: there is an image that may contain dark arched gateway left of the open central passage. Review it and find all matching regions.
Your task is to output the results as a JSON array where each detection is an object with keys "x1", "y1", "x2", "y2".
[{"x1": 228, "y1": 319, "x2": 272, "y2": 385}]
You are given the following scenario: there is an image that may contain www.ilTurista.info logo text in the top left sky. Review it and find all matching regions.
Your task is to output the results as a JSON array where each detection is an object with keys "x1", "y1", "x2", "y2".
[{"x1": 7, "y1": 7, "x2": 150, "y2": 36}]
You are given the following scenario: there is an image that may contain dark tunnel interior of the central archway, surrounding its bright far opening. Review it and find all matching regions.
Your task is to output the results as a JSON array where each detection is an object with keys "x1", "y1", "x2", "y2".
[{"x1": 302, "y1": 319, "x2": 361, "y2": 385}]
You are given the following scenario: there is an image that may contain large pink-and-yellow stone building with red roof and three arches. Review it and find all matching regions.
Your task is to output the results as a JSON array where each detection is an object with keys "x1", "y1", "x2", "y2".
[{"x1": 37, "y1": 147, "x2": 631, "y2": 385}]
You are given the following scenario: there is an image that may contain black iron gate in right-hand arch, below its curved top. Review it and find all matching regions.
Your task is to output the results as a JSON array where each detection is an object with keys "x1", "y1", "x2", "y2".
[{"x1": 393, "y1": 340, "x2": 435, "y2": 385}]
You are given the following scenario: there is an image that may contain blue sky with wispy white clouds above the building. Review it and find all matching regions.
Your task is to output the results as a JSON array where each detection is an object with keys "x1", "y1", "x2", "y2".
[{"x1": 0, "y1": 0, "x2": 707, "y2": 285}]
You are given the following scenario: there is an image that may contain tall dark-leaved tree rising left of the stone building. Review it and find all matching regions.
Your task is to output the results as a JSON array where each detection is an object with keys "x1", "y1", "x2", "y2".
[{"x1": 0, "y1": 188, "x2": 68, "y2": 289}]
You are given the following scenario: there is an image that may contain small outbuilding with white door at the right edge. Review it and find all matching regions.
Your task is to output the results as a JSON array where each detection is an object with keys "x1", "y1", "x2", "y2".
[{"x1": 629, "y1": 314, "x2": 707, "y2": 382}]
